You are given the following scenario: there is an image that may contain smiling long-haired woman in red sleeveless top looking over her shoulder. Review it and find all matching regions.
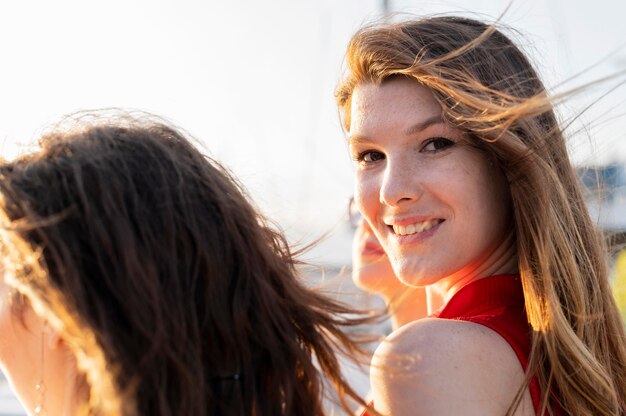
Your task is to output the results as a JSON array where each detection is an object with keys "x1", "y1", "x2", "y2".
[{"x1": 337, "y1": 17, "x2": 626, "y2": 416}]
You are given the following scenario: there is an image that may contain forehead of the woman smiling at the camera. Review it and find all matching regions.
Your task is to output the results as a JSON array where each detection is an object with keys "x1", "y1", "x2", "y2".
[{"x1": 350, "y1": 78, "x2": 442, "y2": 134}]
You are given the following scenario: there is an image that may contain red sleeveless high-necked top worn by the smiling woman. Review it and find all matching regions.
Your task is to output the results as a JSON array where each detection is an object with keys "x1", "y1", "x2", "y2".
[{"x1": 361, "y1": 275, "x2": 561, "y2": 416}]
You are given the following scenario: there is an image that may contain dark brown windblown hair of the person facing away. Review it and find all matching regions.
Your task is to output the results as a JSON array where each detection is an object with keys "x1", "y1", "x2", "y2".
[{"x1": 0, "y1": 118, "x2": 365, "y2": 416}]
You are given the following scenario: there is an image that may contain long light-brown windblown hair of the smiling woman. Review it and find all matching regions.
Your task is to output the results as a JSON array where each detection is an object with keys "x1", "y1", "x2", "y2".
[{"x1": 336, "y1": 17, "x2": 626, "y2": 416}]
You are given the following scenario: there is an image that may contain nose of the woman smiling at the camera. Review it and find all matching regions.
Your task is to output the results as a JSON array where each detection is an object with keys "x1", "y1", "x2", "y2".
[{"x1": 380, "y1": 158, "x2": 422, "y2": 207}]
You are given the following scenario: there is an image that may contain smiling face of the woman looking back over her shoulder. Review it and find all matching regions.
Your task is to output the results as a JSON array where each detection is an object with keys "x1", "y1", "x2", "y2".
[{"x1": 349, "y1": 78, "x2": 516, "y2": 291}]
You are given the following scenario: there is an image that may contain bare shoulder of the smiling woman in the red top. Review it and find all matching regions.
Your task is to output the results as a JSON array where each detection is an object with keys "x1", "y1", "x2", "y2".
[{"x1": 371, "y1": 319, "x2": 534, "y2": 416}]
